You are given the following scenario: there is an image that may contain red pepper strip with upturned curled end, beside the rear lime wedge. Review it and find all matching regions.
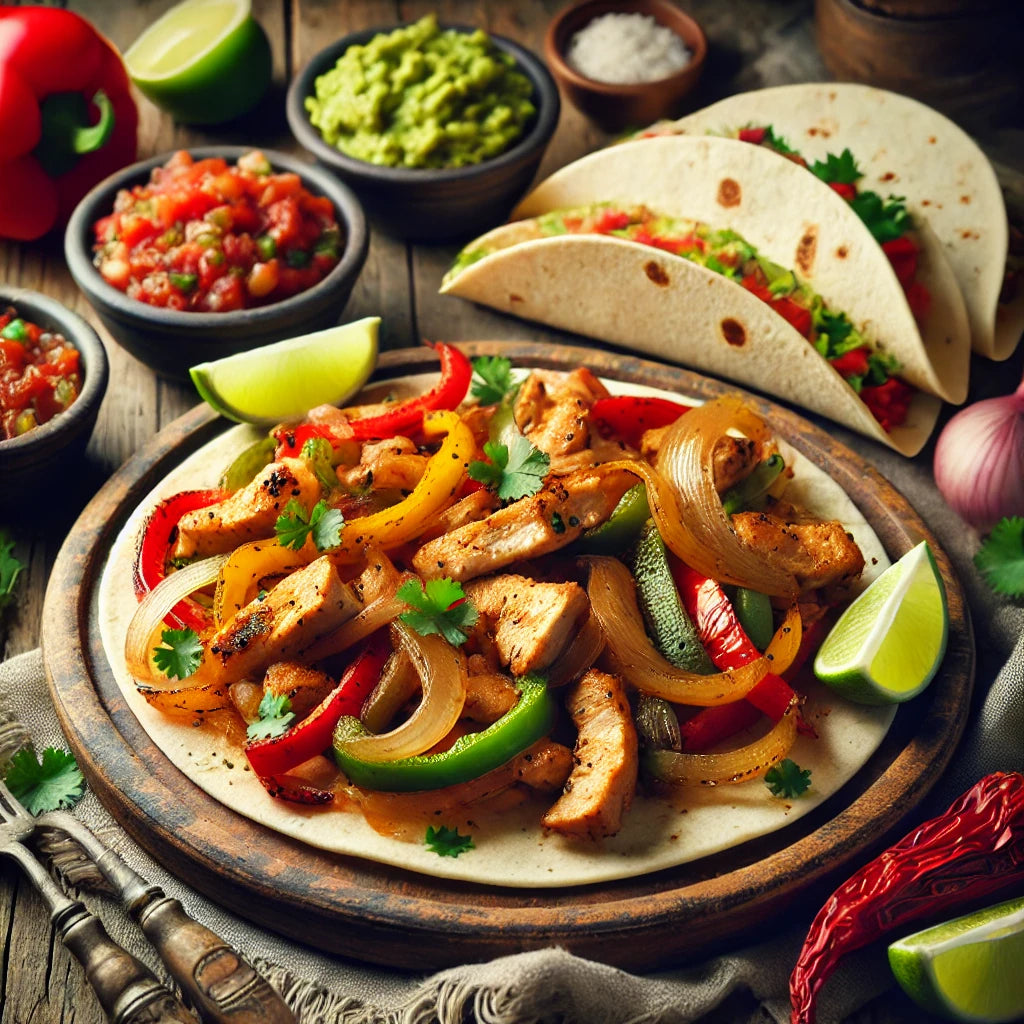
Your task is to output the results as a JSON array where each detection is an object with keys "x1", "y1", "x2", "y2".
[{"x1": 274, "y1": 342, "x2": 473, "y2": 458}]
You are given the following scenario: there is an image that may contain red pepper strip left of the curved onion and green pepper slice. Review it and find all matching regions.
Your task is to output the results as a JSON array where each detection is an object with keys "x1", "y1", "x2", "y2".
[{"x1": 246, "y1": 630, "x2": 391, "y2": 777}]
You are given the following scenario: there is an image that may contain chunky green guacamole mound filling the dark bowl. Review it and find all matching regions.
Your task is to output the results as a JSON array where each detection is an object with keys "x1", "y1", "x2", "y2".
[{"x1": 306, "y1": 14, "x2": 537, "y2": 167}]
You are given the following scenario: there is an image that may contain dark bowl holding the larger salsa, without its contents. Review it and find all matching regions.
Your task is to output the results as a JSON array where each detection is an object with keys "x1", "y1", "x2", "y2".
[{"x1": 65, "y1": 145, "x2": 369, "y2": 378}]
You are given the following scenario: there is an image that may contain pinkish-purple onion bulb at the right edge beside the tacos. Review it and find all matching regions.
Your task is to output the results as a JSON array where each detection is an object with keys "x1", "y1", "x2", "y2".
[{"x1": 935, "y1": 372, "x2": 1024, "y2": 530}]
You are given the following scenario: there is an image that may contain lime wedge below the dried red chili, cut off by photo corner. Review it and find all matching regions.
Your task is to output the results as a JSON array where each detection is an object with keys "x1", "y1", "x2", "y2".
[{"x1": 889, "y1": 898, "x2": 1024, "y2": 1024}]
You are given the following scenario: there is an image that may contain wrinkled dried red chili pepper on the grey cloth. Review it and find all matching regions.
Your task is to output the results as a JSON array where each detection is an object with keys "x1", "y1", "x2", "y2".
[{"x1": 790, "y1": 772, "x2": 1024, "y2": 1024}]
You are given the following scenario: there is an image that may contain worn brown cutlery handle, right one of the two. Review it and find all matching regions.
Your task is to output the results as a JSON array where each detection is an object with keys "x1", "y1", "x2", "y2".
[{"x1": 134, "y1": 889, "x2": 296, "y2": 1024}]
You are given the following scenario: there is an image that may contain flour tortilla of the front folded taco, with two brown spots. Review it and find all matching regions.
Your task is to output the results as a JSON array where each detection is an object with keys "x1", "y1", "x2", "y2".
[{"x1": 441, "y1": 234, "x2": 941, "y2": 456}]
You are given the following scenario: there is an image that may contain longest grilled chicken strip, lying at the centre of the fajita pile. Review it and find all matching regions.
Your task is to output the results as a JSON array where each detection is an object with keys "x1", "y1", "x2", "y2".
[{"x1": 413, "y1": 469, "x2": 636, "y2": 582}]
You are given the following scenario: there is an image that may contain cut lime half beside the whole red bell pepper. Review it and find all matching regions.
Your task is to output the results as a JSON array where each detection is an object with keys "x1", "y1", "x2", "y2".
[{"x1": 124, "y1": 0, "x2": 272, "y2": 124}]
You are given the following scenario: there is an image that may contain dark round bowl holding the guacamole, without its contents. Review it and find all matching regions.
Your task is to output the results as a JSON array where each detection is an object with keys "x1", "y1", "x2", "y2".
[{"x1": 287, "y1": 25, "x2": 560, "y2": 242}]
